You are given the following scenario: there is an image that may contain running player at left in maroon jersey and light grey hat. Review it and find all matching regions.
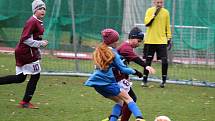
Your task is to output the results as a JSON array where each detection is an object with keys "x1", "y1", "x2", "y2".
[{"x1": 0, "y1": 0, "x2": 48, "y2": 109}]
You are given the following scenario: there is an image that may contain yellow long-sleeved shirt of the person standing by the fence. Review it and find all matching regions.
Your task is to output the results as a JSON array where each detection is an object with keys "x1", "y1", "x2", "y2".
[{"x1": 144, "y1": 7, "x2": 172, "y2": 44}]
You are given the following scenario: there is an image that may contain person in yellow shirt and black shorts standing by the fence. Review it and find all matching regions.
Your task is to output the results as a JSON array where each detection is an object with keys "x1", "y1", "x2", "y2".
[{"x1": 141, "y1": 0, "x2": 172, "y2": 88}]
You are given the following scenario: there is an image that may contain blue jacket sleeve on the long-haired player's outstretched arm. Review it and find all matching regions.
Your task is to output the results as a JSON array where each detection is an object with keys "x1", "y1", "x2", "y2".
[{"x1": 113, "y1": 52, "x2": 135, "y2": 74}]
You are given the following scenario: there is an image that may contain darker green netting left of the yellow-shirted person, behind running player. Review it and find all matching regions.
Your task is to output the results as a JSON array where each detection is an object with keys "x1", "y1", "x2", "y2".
[{"x1": 0, "y1": 0, "x2": 123, "y2": 49}]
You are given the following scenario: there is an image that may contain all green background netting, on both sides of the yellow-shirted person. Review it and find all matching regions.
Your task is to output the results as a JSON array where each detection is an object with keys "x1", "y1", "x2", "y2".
[{"x1": 0, "y1": 0, "x2": 215, "y2": 53}]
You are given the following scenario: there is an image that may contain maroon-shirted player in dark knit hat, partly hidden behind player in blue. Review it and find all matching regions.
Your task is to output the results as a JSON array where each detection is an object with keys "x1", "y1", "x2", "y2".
[{"x1": 102, "y1": 27, "x2": 155, "y2": 121}]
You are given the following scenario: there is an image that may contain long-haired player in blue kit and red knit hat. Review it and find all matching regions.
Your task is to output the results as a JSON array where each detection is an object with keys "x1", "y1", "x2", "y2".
[{"x1": 85, "y1": 29, "x2": 154, "y2": 121}]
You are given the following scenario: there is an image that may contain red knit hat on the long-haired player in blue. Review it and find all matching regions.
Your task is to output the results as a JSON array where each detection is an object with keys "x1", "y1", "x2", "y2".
[{"x1": 101, "y1": 29, "x2": 119, "y2": 45}]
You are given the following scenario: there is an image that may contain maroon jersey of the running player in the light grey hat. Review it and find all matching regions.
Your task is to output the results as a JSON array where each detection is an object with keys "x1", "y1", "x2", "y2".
[{"x1": 15, "y1": 16, "x2": 44, "y2": 66}]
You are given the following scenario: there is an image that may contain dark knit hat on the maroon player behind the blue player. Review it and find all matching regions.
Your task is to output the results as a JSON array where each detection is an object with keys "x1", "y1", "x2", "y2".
[{"x1": 128, "y1": 27, "x2": 144, "y2": 40}]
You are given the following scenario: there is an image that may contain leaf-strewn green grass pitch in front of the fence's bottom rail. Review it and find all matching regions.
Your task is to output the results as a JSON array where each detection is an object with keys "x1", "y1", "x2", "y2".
[{"x1": 0, "y1": 54, "x2": 215, "y2": 121}]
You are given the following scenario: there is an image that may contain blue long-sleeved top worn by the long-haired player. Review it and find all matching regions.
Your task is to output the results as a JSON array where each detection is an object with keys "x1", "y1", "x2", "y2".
[{"x1": 84, "y1": 49, "x2": 135, "y2": 87}]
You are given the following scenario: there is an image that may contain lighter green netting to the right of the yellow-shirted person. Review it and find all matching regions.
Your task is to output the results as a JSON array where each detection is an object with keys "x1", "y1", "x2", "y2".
[{"x1": 166, "y1": 0, "x2": 215, "y2": 53}]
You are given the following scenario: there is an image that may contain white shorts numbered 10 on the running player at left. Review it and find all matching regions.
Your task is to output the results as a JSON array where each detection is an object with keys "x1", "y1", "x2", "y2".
[{"x1": 16, "y1": 60, "x2": 41, "y2": 75}]
